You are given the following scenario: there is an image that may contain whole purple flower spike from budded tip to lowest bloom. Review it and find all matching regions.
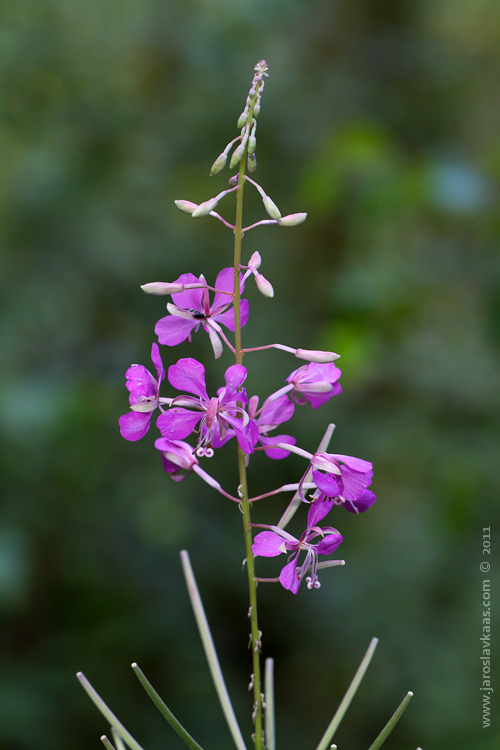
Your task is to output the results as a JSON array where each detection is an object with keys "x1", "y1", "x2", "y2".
[{"x1": 119, "y1": 61, "x2": 375, "y2": 594}]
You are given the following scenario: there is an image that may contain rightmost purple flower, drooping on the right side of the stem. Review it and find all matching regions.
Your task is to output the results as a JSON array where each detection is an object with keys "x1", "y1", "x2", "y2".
[{"x1": 301, "y1": 453, "x2": 376, "y2": 526}]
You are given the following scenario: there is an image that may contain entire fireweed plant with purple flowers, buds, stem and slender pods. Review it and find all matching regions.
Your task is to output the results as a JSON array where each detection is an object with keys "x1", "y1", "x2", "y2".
[{"x1": 78, "y1": 60, "x2": 412, "y2": 750}]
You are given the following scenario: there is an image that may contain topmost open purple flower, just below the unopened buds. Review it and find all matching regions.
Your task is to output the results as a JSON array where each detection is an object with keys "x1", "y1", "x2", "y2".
[{"x1": 155, "y1": 268, "x2": 248, "y2": 359}]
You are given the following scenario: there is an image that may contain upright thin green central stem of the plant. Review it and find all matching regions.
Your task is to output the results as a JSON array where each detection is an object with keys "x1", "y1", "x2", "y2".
[{"x1": 233, "y1": 104, "x2": 263, "y2": 750}]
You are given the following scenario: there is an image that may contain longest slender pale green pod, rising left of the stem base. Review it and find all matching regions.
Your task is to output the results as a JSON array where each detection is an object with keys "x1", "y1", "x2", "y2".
[{"x1": 181, "y1": 550, "x2": 246, "y2": 750}]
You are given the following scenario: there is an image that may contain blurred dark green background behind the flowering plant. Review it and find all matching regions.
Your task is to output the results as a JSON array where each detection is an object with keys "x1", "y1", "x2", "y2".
[{"x1": 0, "y1": 0, "x2": 500, "y2": 750}]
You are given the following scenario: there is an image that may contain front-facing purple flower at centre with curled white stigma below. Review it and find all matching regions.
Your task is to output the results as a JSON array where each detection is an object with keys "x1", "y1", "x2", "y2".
[{"x1": 156, "y1": 357, "x2": 258, "y2": 456}]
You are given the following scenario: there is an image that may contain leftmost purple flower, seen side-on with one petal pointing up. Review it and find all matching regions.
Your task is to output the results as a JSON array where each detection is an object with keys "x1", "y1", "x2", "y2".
[{"x1": 118, "y1": 344, "x2": 164, "y2": 440}]
